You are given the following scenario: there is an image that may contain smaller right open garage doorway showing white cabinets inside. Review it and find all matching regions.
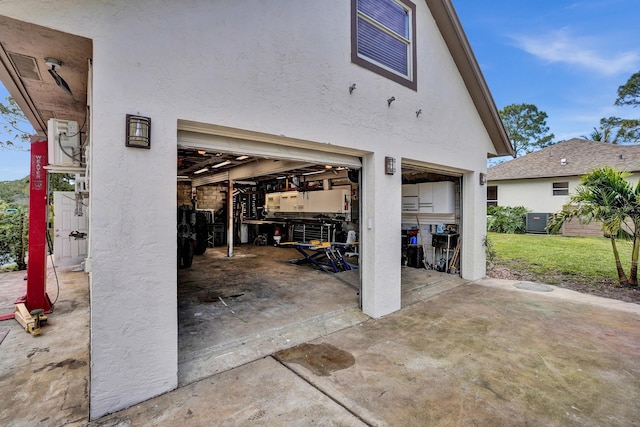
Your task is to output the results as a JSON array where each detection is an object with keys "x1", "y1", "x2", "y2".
[{"x1": 401, "y1": 161, "x2": 463, "y2": 303}]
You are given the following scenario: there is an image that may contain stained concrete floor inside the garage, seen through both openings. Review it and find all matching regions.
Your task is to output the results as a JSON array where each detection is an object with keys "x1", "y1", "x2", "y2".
[{"x1": 178, "y1": 245, "x2": 462, "y2": 385}]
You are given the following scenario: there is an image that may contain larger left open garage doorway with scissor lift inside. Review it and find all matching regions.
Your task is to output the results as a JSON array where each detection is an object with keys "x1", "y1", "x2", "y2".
[{"x1": 176, "y1": 133, "x2": 366, "y2": 384}]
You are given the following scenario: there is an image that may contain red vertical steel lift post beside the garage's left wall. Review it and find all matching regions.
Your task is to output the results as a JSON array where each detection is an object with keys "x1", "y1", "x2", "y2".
[{"x1": 25, "y1": 136, "x2": 51, "y2": 312}]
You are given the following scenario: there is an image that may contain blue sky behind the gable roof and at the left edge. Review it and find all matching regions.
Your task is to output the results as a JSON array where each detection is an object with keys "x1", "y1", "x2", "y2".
[{"x1": 0, "y1": 0, "x2": 640, "y2": 181}]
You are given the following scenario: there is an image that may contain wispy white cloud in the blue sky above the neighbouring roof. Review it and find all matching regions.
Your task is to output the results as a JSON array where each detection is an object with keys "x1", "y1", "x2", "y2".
[{"x1": 511, "y1": 29, "x2": 640, "y2": 76}]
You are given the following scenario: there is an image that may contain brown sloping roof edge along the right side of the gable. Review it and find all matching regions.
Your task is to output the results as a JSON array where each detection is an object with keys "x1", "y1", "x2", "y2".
[{"x1": 426, "y1": 0, "x2": 515, "y2": 156}]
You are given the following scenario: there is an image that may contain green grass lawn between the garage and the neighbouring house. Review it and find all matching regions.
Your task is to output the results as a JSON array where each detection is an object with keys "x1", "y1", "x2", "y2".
[{"x1": 487, "y1": 233, "x2": 631, "y2": 284}]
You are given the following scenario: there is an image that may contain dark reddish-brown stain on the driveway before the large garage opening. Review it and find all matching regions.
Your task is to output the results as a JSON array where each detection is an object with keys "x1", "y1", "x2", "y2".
[{"x1": 274, "y1": 344, "x2": 356, "y2": 377}]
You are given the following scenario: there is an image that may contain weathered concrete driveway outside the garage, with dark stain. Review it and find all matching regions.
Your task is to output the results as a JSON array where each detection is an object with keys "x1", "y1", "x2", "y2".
[{"x1": 0, "y1": 273, "x2": 640, "y2": 427}]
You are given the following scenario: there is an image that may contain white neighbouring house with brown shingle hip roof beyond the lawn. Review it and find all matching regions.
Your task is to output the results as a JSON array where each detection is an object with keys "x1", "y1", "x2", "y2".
[{"x1": 487, "y1": 138, "x2": 640, "y2": 235}]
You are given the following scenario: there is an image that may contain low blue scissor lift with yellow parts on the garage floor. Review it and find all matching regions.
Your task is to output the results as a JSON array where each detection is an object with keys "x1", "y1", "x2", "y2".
[{"x1": 279, "y1": 242, "x2": 358, "y2": 273}]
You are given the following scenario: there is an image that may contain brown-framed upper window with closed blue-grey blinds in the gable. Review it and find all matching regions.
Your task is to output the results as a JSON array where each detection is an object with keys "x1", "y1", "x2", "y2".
[{"x1": 351, "y1": 0, "x2": 417, "y2": 90}]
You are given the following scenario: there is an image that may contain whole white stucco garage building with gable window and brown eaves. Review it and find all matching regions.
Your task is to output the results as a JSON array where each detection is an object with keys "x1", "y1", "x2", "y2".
[{"x1": 0, "y1": 0, "x2": 513, "y2": 418}]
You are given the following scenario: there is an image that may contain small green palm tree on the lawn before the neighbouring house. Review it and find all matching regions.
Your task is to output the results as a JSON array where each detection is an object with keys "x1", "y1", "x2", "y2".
[{"x1": 549, "y1": 166, "x2": 640, "y2": 286}]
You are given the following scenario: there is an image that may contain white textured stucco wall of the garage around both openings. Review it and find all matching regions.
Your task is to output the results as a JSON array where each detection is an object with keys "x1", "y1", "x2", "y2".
[{"x1": 0, "y1": 0, "x2": 502, "y2": 418}]
